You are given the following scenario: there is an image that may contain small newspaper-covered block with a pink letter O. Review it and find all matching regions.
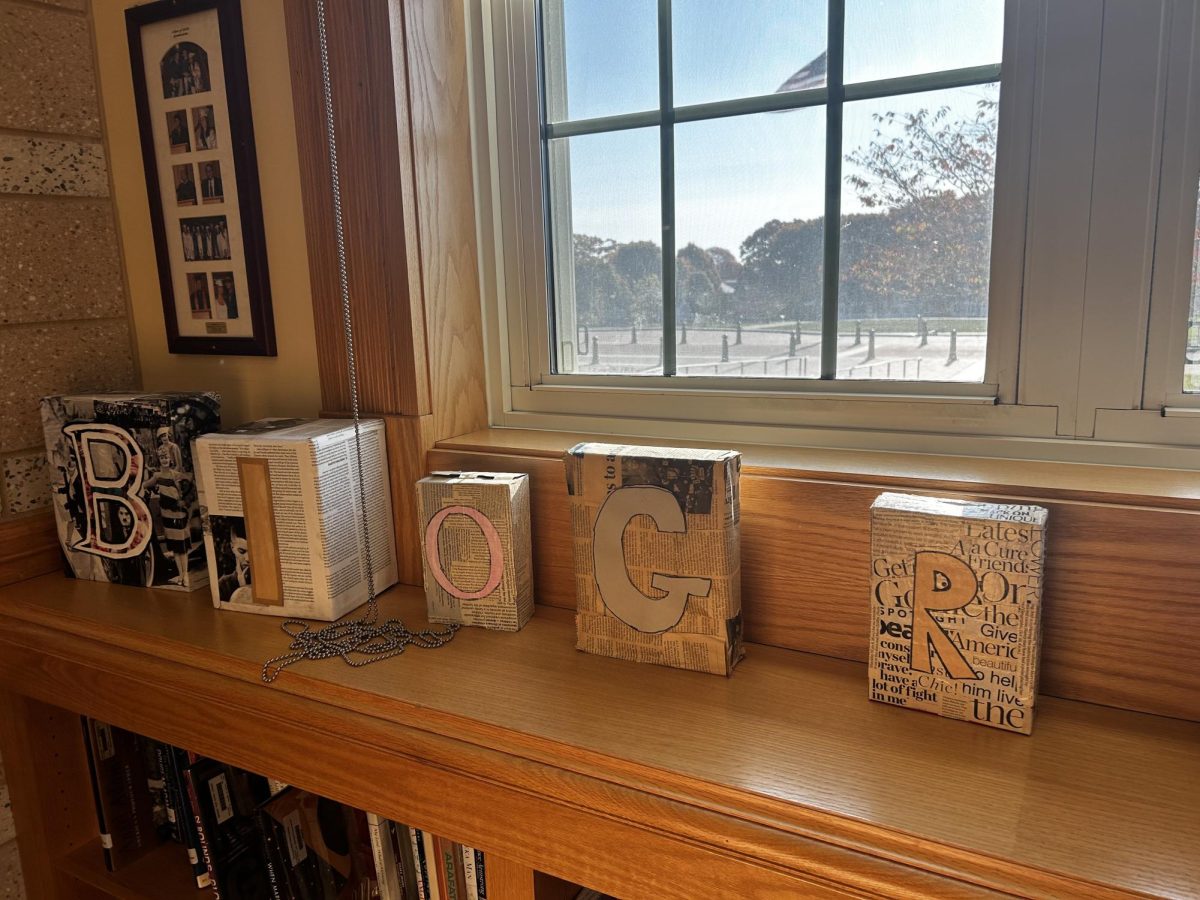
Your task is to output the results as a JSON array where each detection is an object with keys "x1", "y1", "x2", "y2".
[{"x1": 416, "y1": 472, "x2": 533, "y2": 631}]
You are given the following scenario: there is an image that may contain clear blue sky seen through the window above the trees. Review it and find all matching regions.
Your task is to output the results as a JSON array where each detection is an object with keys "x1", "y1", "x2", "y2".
[{"x1": 546, "y1": 0, "x2": 1003, "y2": 252}]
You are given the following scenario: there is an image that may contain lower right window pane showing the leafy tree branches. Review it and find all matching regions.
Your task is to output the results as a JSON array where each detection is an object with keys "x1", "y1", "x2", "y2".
[{"x1": 838, "y1": 84, "x2": 1000, "y2": 382}]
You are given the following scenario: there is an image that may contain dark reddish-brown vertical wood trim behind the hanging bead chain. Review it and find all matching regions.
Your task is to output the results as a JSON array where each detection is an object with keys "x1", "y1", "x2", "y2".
[{"x1": 286, "y1": 0, "x2": 429, "y2": 415}]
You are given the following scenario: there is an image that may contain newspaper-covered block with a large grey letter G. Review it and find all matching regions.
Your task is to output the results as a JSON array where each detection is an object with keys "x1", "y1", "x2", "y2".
[{"x1": 565, "y1": 444, "x2": 743, "y2": 674}]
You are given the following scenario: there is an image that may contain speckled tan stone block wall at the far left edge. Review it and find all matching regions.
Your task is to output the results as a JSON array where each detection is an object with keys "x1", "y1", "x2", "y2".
[{"x1": 0, "y1": 0, "x2": 137, "y2": 900}]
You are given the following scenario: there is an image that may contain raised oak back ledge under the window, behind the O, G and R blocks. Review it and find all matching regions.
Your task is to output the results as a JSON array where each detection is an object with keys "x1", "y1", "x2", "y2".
[{"x1": 426, "y1": 428, "x2": 1200, "y2": 721}]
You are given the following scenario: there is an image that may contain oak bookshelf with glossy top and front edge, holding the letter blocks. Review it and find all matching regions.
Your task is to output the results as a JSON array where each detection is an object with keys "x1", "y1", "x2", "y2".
[{"x1": 0, "y1": 576, "x2": 1200, "y2": 900}]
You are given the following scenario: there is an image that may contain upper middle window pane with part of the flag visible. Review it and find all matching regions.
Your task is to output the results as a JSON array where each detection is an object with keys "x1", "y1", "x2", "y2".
[{"x1": 671, "y1": 0, "x2": 828, "y2": 106}]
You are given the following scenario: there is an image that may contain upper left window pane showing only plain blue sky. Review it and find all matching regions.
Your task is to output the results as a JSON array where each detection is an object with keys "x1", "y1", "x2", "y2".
[{"x1": 542, "y1": 0, "x2": 659, "y2": 122}]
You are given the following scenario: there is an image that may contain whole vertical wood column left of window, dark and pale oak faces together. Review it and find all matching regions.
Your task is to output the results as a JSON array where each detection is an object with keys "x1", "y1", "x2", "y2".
[{"x1": 286, "y1": 0, "x2": 487, "y2": 584}]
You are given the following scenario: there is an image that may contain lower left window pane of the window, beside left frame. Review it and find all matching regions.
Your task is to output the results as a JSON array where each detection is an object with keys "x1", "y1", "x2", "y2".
[{"x1": 548, "y1": 128, "x2": 662, "y2": 374}]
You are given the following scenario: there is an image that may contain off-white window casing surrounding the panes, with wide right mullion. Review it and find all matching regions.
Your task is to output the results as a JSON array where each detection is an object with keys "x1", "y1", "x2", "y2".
[{"x1": 464, "y1": 0, "x2": 1200, "y2": 468}]
